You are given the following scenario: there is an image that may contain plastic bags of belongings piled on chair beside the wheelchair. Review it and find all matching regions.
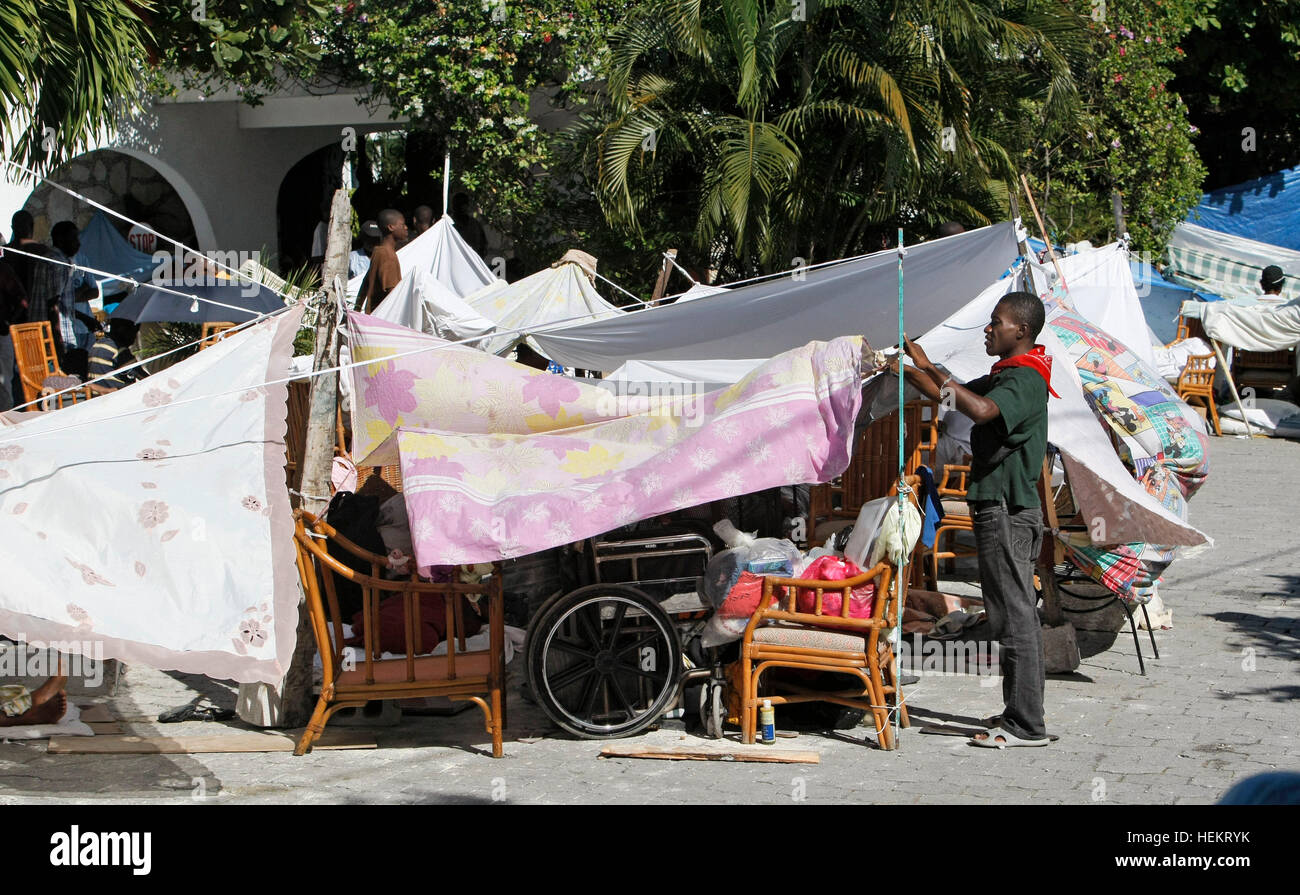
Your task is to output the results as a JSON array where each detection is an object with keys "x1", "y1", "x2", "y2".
[{"x1": 701, "y1": 497, "x2": 922, "y2": 647}]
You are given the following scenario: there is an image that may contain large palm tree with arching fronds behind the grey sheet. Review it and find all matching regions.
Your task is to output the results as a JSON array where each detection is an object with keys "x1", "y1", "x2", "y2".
[{"x1": 585, "y1": 0, "x2": 1084, "y2": 274}]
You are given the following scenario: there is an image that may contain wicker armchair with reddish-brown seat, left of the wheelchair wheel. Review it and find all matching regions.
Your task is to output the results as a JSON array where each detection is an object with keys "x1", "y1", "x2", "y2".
[{"x1": 294, "y1": 510, "x2": 506, "y2": 758}]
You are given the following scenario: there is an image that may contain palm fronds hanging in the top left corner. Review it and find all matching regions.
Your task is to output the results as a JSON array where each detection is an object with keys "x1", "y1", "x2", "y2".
[{"x1": 0, "y1": 0, "x2": 152, "y2": 169}]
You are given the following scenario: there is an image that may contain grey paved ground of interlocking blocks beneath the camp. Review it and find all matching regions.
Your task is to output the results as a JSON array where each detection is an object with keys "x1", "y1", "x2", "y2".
[{"x1": 0, "y1": 438, "x2": 1300, "y2": 804}]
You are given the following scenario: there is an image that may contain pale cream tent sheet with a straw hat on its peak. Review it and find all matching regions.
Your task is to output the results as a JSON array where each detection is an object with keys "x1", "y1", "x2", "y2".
[{"x1": 465, "y1": 254, "x2": 624, "y2": 356}]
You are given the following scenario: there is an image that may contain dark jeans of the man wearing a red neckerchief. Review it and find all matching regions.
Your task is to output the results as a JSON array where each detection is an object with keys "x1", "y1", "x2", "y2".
[{"x1": 971, "y1": 501, "x2": 1047, "y2": 739}]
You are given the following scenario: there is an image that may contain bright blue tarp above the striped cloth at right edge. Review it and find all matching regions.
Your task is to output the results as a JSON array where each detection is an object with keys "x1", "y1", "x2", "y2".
[{"x1": 1187, "y1": 168, "x2": 1300, "y2": 251}]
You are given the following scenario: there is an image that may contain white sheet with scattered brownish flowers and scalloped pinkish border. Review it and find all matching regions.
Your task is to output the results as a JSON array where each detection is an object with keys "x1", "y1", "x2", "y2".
[{"x1": 0, "y1": 308, "x2": 302, "y2": 683}]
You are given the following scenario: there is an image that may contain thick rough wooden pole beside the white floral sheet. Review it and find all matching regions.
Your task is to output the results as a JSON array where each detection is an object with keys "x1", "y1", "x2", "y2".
[{"x1": 238, "y1": 189, "x2": 352, "y2": 727}]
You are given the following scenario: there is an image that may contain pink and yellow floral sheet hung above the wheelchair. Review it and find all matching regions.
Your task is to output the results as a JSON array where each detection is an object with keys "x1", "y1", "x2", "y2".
[{"x1": 348, "y1": 314, "x2": 863, "y2": 567}]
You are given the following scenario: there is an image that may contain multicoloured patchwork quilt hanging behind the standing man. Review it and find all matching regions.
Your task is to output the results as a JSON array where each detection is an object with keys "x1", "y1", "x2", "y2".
[{"x1": 1045, "y1": 295, "x2": 1209, "y2": 602}]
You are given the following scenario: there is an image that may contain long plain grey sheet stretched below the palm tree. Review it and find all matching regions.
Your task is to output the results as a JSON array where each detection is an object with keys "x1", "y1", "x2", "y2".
[{"x1": 530, "y1": 224, "x2": 1017, "y2": 372}]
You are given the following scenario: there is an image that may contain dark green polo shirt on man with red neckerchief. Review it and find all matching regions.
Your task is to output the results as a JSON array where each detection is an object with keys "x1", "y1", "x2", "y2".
[{"x1": 966, "y1": 367, "x2": 1048, "y2": 510}]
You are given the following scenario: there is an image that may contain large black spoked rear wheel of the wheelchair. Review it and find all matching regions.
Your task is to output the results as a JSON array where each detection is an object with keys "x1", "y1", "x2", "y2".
[{"x1": 528, "y1": 584, "x2": 681, "y2": 739}]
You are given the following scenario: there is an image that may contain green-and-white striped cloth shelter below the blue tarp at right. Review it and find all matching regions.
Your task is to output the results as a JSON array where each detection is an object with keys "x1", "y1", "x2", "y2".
[{"x1": 1165, "y1": 224, "x2": 1300, "y2": 304}]
